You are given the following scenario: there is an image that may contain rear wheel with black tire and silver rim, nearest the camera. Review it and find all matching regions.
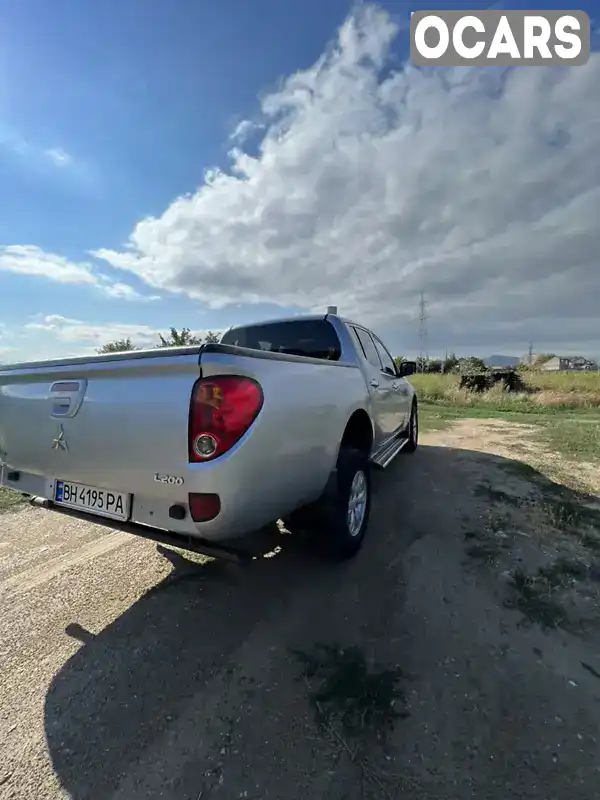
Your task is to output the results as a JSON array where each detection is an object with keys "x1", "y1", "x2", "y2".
[{"x1": 312, "y1": 445, "x2": 371, "y2": 561}]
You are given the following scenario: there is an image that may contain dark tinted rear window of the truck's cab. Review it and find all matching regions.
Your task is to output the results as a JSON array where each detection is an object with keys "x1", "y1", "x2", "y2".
[{"x1": 221, "y1": 319, "x2": 342, "y2": 361}]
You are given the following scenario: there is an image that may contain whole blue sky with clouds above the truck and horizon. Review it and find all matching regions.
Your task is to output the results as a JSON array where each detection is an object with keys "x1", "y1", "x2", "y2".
[{"x1": 0, "y1": 0, "x2": 600, "y2": 360}]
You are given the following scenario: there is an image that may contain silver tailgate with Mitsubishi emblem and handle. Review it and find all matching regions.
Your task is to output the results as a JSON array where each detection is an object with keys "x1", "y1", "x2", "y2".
[{"x1": 0, "y1": 347, "x2": 200, "y2": 497}]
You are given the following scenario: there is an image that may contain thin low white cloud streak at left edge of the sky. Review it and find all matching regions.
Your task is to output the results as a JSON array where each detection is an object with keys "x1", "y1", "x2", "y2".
[{"x1": 0, "y1": 245, "x2": 157, "y2": 302}]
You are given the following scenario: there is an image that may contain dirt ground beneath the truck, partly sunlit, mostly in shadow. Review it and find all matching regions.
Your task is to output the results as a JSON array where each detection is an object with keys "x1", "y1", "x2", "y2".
[{"x1": 0, "y1": 420, "x2": 600, "y2": 800}]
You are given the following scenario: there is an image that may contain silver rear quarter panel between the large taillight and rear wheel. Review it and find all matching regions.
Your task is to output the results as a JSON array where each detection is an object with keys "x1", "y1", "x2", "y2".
[{"x1": 193, "y1": 348, "x2": 366, "y2": 524}]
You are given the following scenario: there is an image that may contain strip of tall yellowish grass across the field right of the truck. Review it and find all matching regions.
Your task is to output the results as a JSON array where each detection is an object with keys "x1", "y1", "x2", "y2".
[{"x1": 410, "y1": 371, "x2": 600, "y2": 414}]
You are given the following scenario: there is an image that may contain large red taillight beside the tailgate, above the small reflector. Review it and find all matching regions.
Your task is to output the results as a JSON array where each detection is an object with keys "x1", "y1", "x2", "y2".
[{"x1": 188, "y1": 375, "x2": 263, "y2": 463}]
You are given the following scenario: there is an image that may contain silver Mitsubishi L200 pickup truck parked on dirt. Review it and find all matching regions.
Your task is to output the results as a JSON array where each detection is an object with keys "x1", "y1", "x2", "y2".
[{"x1": 0, "y1": 309, "x2": 418, "y2": 558}]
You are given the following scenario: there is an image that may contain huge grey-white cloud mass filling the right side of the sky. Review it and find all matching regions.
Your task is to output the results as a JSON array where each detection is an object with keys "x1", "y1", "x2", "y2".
[{"x1": 86, "y1": 6, "x2": 600, "y2": 354}]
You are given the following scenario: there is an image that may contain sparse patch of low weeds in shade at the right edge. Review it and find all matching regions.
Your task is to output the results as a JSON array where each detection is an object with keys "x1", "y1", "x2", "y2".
[{"x1": 465, "y1": 464, "x2": 600, "y2": 633}]
